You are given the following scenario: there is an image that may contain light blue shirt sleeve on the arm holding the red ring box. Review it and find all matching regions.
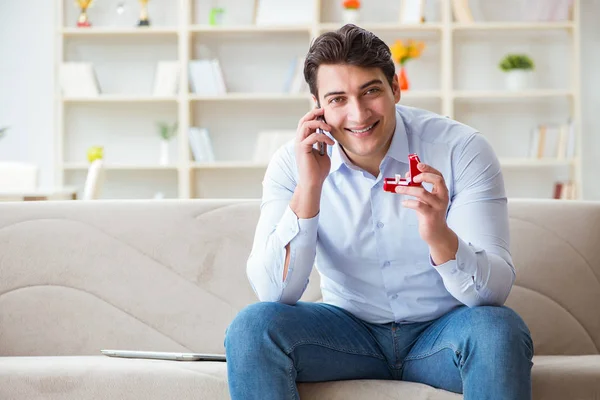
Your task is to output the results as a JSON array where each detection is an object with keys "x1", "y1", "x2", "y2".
[{"x1": 430, "y1": 134, "x2": 516, "y2": 307}]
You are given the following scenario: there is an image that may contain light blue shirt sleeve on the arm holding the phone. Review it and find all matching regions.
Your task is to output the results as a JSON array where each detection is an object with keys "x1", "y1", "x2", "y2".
[{"x1": 246, "y1": 143, "x2": 319, "y2": 304}]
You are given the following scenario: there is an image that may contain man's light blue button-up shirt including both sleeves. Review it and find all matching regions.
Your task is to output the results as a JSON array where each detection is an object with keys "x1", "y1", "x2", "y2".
[{"x1": 247, "y1": 105, "x2": 515, "y2": 323}]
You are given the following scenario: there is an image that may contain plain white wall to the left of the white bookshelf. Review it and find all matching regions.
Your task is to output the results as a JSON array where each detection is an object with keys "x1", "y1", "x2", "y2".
[{"x1": 0, "y1": 0, "x2": 55, "y2": 186}]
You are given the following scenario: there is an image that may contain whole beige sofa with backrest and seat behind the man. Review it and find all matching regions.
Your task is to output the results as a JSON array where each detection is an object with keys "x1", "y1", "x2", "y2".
[{"x1": 0, "y1": 200, "x2": 600, "y2": 400}]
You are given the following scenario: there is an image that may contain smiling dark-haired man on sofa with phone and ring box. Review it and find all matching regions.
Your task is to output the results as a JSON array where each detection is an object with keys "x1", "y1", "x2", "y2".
[{"x1": 225, "y1": 25, "x2": 533, "y2": 400}]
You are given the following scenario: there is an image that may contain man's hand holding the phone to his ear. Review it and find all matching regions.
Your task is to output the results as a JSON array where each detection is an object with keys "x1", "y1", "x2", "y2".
[{"x1": 295, "y1": 108, "x2": 335, "y2": 191}]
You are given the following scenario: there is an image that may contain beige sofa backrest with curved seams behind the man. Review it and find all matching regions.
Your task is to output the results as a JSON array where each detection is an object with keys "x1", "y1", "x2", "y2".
[{"x1": 0, "y1": 200, "x2": 600, "y2": 356}]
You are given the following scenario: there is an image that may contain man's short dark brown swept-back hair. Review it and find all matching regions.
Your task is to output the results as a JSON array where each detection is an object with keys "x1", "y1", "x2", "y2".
[{"x1": 304, "y1": 24, "x2": 396, "y2": 97}]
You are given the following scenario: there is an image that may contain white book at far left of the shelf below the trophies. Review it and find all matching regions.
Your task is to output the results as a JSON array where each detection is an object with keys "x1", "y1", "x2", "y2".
[{"x1": 59, "y1": 62, "x2": 100, "y2": 97}]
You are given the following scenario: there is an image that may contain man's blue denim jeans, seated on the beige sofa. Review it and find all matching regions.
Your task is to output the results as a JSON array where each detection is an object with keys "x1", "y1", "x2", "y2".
[{"x1": 225, "y1": 302, "x2": 533, "y2": 400}]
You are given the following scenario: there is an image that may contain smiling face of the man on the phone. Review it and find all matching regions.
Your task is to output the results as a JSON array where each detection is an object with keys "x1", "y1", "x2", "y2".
[{"x1": 317, "y1": 64, "x2": 400, "y2": 166}]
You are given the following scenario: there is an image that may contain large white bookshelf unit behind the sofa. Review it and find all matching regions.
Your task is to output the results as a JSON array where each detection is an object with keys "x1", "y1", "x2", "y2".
[{"x1": 55, "y1": 0, "x2": 582, "y2": 199}]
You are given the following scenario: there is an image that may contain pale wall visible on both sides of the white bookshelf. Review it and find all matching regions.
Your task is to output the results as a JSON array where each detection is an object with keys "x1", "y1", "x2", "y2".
[{"x1": 0, "y1": 0, "x2": 600, "y2": 200}]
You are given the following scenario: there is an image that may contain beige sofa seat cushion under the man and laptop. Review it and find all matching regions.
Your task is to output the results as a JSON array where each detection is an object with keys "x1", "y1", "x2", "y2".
[{"x1": 0, "y1": 355, "x2": 600, "y2": 400}]
